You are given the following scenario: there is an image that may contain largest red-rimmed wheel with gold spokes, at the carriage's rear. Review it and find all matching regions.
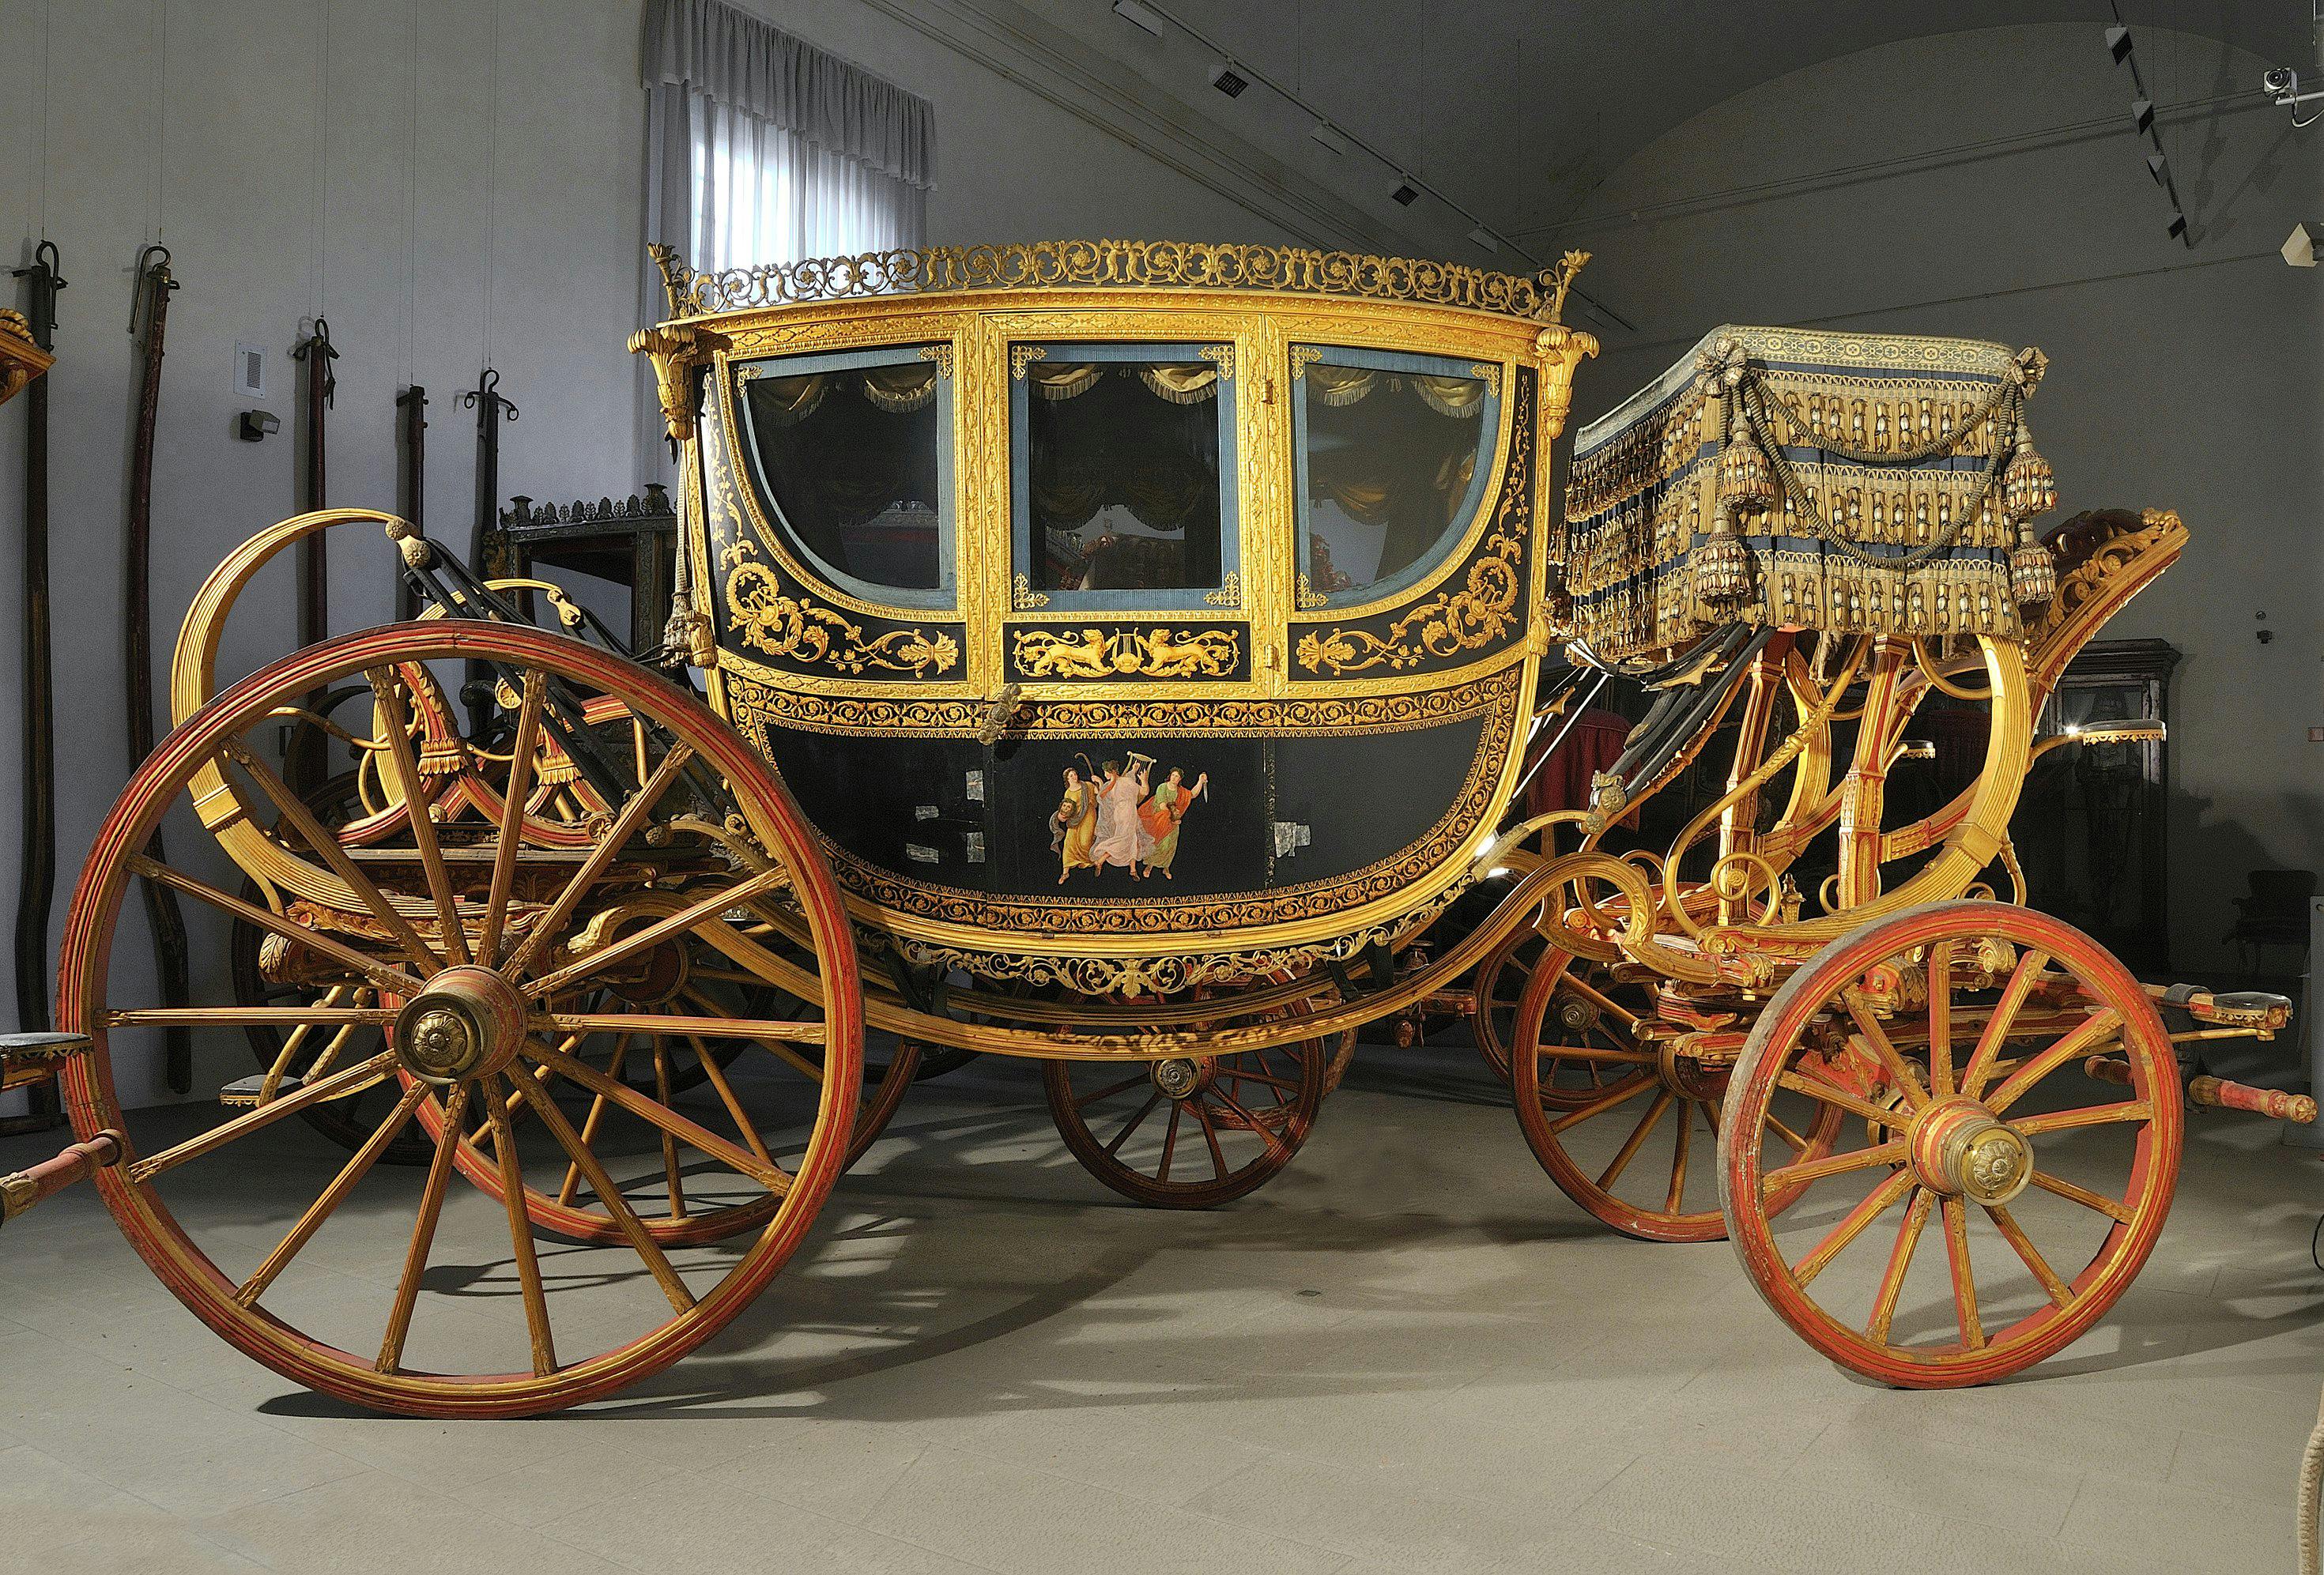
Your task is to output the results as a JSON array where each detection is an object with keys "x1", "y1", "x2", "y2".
[{"x1": 58, "y1": 623, "x2": 862, "y2": 1417}]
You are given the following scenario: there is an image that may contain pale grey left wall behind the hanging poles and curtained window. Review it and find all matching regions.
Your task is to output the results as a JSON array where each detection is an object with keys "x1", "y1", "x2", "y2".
[{"x1": 0, "y1": 0, "x2": 1281, "y2": 1101}]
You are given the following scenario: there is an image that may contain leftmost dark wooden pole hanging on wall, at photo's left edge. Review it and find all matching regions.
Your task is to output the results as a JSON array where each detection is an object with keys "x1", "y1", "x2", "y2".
[{"x1": 0, "y1": 242, "x2": 65, "y2": 1136}]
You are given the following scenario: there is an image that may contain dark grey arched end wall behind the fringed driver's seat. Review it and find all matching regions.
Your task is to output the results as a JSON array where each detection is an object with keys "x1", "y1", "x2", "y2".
[{"x1": 1557, "y1": 23, "x2": 2324, "y2": 974}]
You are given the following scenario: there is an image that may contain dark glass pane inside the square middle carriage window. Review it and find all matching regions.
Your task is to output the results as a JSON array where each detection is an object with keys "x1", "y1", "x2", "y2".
[{"x1": 1023, "y1": 356, "x2": 1222, "y2": 593}]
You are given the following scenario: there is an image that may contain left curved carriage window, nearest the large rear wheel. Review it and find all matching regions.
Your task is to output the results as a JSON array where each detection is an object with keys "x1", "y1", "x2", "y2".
[{"x1": 737, "y1": 346, "x2": 953, "y2": 604}]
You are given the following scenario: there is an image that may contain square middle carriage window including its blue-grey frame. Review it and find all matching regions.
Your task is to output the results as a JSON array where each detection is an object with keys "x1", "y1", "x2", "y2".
[{"x1": 1011, "y1": 344, "x2": 1234, "y2": 606}]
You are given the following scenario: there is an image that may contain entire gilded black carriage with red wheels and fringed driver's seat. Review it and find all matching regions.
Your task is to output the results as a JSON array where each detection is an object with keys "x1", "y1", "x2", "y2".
[{"x1": 0, "y1": 242, "x2": 2315, "y2": 1415}]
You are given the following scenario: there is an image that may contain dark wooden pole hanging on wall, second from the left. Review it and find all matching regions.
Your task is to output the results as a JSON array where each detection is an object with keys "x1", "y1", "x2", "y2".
[{"x1": 121, "y1": 247, "x2": 193, "y2": 1095}]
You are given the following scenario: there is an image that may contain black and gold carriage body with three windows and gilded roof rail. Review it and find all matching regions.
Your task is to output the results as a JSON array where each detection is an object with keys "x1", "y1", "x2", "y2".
[{"x1": 643, "y1": 244, "x2": 1594, "y2": 992}]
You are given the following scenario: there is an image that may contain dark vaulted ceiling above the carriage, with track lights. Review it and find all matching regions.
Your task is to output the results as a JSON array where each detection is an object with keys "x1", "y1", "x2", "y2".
[{"x1": 1025, "y1": 0, "x2": 2315, "y2": 260}]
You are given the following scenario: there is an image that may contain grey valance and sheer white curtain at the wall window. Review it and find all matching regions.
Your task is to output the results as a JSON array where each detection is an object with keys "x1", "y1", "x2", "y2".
[{"x1": 639, "y1": 0, "x2": 937, "y2": 479}]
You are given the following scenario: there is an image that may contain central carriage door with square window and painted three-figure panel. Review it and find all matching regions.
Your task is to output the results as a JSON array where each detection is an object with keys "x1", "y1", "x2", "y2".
[{"x1": 994, "y1": 332, "x2": 1273, "y2": 899}]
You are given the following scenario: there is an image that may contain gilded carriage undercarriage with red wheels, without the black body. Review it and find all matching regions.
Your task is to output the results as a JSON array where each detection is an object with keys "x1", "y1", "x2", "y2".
[{"x1": 0, "y1": 246, "x2": 2315, "y2": 1415}]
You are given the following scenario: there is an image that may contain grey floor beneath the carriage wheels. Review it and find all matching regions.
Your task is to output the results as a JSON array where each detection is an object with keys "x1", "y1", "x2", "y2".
[{"x1": 0, "y1": 1050, "x2": 2324, "y2": 1575}]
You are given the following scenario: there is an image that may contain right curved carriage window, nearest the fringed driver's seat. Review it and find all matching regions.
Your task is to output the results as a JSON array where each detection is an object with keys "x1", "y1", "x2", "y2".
[{"x1": 1292, "y1": 346, "x2": 1501, "y2": 606}]
